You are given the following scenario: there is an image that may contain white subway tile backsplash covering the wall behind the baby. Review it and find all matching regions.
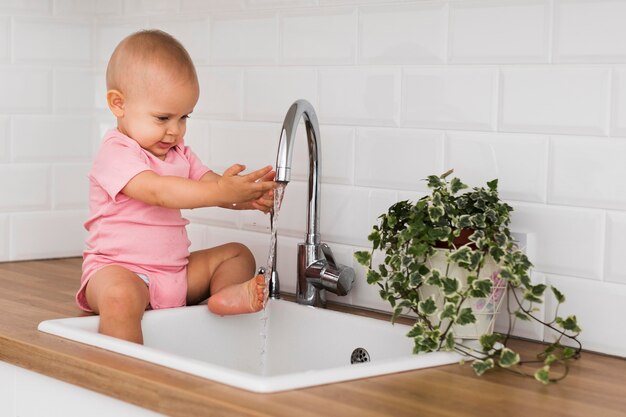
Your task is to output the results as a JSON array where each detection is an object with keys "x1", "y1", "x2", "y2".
[{"x1": 0, "y1": 0, "x2": 626, "y2": 356}]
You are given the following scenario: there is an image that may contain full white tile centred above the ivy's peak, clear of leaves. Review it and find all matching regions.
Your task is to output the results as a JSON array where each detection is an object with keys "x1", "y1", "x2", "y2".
[{"x1": 402, "y1": 67, "x2": 497, "y2": 130}]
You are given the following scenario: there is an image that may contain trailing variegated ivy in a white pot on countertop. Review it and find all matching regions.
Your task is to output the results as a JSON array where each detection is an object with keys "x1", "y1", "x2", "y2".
[{"x1": 355, "y1": 170, "x2": 582, "y2": 384}]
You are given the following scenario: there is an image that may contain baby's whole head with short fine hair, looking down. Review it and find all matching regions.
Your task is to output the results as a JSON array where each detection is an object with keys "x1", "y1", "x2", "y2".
[{"x1": 106, "y1": 30, "x2": 199, "y2": 159}]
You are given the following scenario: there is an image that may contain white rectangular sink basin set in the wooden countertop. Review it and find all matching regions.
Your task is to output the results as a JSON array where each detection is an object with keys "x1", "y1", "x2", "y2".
[{"x1": 39, "y1": 300, "x2": 461, "y2": 392}]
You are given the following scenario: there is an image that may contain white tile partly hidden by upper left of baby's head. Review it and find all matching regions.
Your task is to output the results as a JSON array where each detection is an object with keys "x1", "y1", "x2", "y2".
[{"x1": 93, "y1": 17, "x2": 149, "y2": 63}]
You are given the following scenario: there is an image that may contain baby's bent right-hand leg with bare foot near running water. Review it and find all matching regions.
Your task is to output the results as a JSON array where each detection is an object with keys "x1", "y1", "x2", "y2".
[{"x1": 187, "y1": 243, "x2": 265, "y2": 315}]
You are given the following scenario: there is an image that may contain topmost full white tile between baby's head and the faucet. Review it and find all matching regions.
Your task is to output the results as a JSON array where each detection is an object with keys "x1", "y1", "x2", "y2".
[{"x1": 210, "y1": 12, "x2": 278, "y2": 65}]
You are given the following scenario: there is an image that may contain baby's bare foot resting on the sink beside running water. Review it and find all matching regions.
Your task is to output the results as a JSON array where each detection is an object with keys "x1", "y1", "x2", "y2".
[{"x1": 208, "y1": 275, "x2": 265, "y2": 316}]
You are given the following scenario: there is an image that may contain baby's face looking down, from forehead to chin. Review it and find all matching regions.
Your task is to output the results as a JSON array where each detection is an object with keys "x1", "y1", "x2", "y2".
[{"x1": 117, "y1": 71, "x2": 199, "y2": 159}]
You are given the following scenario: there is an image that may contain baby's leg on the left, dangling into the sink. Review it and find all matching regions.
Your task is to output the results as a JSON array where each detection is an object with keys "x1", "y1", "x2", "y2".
[{"x1": 86, "y1": 265, "x2": 150, "y2": 344}]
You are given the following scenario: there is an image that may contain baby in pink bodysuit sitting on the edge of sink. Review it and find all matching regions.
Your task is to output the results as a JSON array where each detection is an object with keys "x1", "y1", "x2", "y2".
[{"x1": 76, "y1": 30, "x2": 275, "y2": 343}]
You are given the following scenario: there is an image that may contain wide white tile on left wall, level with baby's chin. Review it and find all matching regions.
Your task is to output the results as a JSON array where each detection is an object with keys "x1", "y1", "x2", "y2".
[{"x1": 11, "y1": 116, "x2": 93, "y2": 162}]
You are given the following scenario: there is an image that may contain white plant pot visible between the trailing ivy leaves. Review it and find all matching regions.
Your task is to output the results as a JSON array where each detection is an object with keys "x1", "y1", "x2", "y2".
[{"x1": 419, "y1": 249, "x2": 506, "y2": 339}]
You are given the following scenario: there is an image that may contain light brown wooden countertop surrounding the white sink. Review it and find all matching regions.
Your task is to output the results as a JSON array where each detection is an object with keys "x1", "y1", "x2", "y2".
[{"x1": 0, "y1": 258, "x2": 626, "y2": 417}]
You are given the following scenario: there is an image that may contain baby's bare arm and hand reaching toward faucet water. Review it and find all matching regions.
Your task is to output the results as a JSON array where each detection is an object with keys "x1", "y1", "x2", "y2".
[{"x1": 122, "y1": 165, "x2": 275, "y2": 209}]
